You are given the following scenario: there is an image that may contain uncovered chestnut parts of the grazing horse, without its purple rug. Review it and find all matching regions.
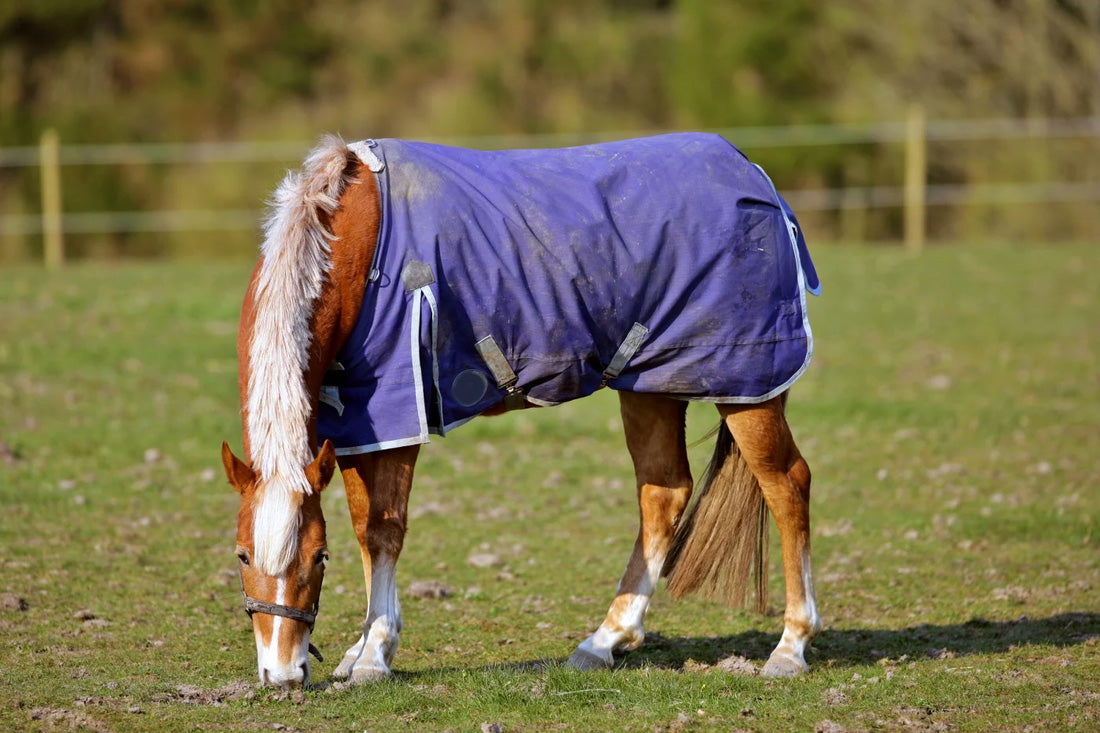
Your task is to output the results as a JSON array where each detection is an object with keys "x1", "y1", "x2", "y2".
[{"x1": 222, "y1": 138, "x2": 822, "y2": 688}]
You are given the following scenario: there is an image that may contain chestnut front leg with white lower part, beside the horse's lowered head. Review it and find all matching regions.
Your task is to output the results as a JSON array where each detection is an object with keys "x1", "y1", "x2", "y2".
[{"x1": 332, "y1": 446, "x2": 420, "y2": 682}]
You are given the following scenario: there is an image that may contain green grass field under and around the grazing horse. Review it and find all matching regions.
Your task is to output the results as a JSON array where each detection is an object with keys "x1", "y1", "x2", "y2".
[{"x1": 0, "y1": 245, "x2": 1100, "y2": 731}]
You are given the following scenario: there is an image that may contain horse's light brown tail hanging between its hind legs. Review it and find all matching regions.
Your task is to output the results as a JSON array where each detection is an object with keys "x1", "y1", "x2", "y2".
[{"x1": 663, "y1": 423, "x2": 768, "y2": 613}]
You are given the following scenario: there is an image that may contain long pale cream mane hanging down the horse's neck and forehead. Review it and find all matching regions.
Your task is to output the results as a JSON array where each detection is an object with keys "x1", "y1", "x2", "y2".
[{"x1": 244, "y1": 135, "x2": 350, "y2": 567}]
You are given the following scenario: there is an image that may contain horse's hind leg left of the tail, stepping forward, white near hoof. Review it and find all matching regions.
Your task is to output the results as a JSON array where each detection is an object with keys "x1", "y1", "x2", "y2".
[{"x1": 569, "y1": 392, "x2": 692, "y2": 669}]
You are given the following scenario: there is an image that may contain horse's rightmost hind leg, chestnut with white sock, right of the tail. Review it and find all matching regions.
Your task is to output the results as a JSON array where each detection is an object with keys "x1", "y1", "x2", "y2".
[{"x1": 719, "y1": 397, "x2": 822, "y2": 677}]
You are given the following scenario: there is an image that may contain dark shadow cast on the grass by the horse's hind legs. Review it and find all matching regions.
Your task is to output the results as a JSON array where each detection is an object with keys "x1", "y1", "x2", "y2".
[{"x1": 620, "y1": 613, "x2": 1100, "y2": 669}]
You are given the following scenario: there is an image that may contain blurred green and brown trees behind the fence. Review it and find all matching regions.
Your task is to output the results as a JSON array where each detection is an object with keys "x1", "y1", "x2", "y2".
[{"x1": 0, "y1": 0, "x2": 1100, "y2": 258}]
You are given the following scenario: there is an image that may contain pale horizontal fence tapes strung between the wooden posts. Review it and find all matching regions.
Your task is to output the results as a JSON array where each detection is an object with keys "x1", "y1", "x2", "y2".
[{"x1": 0, "y1": 117, "x2": 1100, "y2": 236}]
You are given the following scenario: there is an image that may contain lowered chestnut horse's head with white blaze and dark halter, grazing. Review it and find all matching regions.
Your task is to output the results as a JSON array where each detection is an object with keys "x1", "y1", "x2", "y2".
[{"x1": 215, "y1": 440, "x2": 336, "y2": 688}]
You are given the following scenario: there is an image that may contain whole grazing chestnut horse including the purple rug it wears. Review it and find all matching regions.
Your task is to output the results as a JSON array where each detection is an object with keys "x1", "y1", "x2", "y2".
[{"x1": 222, "y1": 133, "x2": 822, "y2": 688}]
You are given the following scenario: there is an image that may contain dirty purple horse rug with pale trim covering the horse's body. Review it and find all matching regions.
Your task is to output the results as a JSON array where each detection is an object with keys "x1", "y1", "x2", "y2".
[{"x1": 318, "y1": 134, "x2": 820, "y2": 455}]
